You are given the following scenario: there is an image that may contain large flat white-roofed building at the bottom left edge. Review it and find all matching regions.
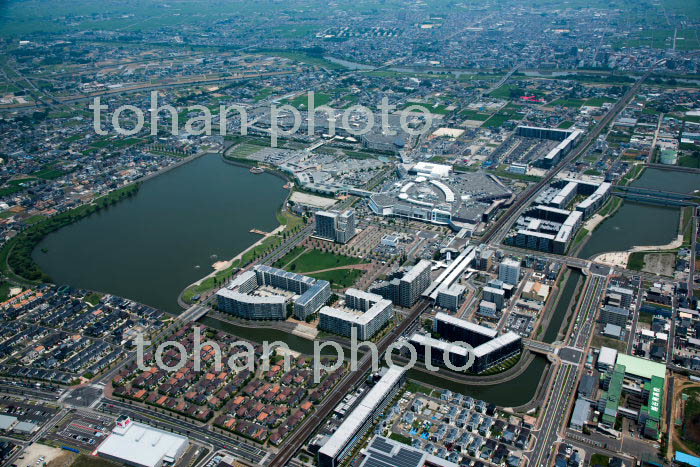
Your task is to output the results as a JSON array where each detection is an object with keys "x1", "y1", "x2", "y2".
[{"x1": 97, "y1": 415, "x2": 189, "y2": 467}]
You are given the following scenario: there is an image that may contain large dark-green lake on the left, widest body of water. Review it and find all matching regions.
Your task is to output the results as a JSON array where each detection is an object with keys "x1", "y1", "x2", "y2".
[{"x1": 33, "y1": 154, "x2": 287, "y2": 313}]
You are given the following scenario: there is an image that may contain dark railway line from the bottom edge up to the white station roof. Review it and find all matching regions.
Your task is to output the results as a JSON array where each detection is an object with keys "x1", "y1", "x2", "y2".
[{"x1": 270, "y1": 299, "x2": 430, "y2": 467}]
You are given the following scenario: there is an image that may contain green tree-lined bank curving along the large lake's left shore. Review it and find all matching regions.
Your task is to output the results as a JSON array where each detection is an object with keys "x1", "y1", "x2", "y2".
[{"x1": 0, "y1": 184, "x2": 140, "y2": 283}]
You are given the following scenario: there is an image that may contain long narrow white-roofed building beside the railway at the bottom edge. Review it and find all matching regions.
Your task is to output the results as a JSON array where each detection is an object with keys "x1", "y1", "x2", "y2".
[{"x1": 318, "y1": 366, "x2": 406, "y2": 467}]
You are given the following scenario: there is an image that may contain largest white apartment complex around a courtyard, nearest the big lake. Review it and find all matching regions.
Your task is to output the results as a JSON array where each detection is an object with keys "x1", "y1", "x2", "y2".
[{"x1": 216, "y1": 265, "x2": 331, "y2": 320}]
